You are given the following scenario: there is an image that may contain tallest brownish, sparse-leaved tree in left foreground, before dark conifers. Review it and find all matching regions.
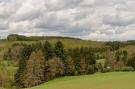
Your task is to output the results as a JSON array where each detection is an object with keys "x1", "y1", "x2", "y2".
[{"x1": 23, "y1": 50, "x2": 45, "y2": 87}]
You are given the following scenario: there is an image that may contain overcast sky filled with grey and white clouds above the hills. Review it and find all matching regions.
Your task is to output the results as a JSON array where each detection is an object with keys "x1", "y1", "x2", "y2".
[{"x1": 0, "y1": 0, "x2": 135, "y2": 41}]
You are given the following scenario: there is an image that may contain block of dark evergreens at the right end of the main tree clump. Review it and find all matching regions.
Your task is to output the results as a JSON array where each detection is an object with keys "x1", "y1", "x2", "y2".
[{"x1": 68, "y1": 47, "x2": 96, "y2": 74}]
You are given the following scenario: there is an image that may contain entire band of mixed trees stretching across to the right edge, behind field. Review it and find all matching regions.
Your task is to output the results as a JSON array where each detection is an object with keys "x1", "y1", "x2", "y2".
[{"x1": 4, "y1": 41, "x2": 135, "y2": 88}]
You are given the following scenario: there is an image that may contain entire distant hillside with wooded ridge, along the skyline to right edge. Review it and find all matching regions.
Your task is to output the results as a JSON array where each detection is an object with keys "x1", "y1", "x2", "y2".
[{"x1": 4, "y1": 34, "x2": 135, "y2": 50}]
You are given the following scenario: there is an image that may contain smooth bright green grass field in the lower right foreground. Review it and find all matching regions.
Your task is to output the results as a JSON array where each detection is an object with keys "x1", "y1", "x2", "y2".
[{"x1": 27, "y1": 72, "x2": 135, "y2": 89}]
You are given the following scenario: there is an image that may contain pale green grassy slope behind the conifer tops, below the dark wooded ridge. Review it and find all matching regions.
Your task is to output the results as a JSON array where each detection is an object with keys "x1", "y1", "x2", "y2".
[{"x1": 0, "y1": 38, "x2": 105, "y2": 48}]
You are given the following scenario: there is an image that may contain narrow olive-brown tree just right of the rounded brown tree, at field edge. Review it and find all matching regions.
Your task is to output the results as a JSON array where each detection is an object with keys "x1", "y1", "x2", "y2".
[{"x1": 65, "y1": 57, "x2": 76, "y2": 75}]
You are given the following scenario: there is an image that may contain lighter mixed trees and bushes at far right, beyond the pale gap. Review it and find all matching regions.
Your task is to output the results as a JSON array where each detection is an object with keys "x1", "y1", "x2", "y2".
[{"x1": 103, "y1": 50, "x2": 135, "y2": 72}]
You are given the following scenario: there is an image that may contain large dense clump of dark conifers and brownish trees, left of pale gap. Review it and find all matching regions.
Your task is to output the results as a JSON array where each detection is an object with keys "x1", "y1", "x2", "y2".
[{"x1": 4, "y1": 41, "x2": 98, "y2": 88}]
